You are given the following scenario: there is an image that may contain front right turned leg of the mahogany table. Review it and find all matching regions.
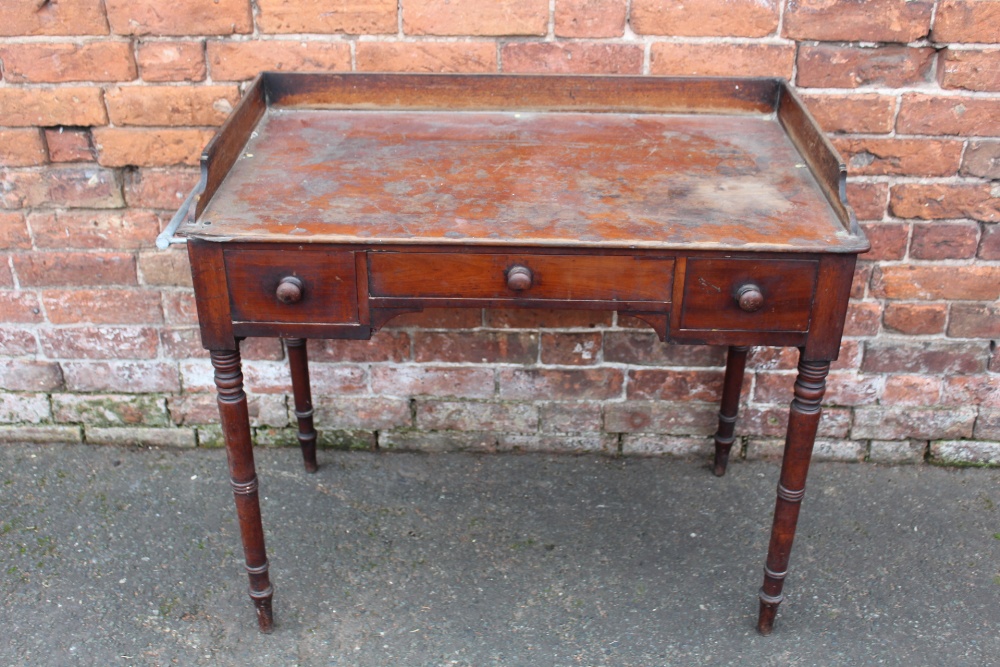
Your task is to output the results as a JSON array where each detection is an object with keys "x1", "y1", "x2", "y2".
[{"x1": 757, "y1": 359, "x2": 830, "y2": 635}]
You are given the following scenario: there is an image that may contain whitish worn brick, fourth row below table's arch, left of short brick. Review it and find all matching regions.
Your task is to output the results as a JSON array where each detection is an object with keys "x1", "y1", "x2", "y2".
[{"x1": 416, "y1": 401, "x2": 538, "y2": 433}]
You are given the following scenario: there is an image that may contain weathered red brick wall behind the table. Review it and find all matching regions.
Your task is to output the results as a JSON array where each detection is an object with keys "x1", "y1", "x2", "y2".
[{"x1": 0, "y1": 0, "x2": 1000, "y2": 462}]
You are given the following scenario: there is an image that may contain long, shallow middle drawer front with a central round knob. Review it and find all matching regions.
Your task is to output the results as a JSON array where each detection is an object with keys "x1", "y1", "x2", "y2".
[{"x1": 368, "y1": 252, "x2": 674, "y2": 303}]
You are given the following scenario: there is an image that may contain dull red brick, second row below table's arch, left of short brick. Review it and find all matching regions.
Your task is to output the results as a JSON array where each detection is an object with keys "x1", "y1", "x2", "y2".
[{"x1": 413, "y1": 331, "x2": 538, "y2": 364}]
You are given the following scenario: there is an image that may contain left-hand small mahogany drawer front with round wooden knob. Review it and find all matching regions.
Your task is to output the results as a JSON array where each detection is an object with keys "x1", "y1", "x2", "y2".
[{"x1": 225, "y1": 248, "x2": 358, "y2": 324}]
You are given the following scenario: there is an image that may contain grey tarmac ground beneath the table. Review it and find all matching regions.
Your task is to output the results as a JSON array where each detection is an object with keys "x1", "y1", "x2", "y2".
[{"x1": 0, "y1": 445, "x2": 1000, "y2": 667}]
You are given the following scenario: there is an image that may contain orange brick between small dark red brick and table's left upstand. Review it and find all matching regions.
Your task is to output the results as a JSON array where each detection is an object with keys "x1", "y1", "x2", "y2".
[{"x1": 94, "y1": 127, "x2": 215, "y2": 167}]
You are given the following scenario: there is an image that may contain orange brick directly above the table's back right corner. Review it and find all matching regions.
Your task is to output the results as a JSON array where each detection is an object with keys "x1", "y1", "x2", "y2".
[{"x1": 649, "y1": 42, "x2": 795, "y2": 79}]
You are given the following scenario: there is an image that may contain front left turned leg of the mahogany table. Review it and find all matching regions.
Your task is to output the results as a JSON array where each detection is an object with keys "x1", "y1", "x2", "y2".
[{"x1": 211, "y1": 343, "x2": 274, "y2": 632}]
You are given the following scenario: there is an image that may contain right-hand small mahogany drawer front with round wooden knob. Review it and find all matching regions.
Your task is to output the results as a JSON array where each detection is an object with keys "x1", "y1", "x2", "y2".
[{"x1": 680, "y1": 258, "x2": 819, "y2": 332}]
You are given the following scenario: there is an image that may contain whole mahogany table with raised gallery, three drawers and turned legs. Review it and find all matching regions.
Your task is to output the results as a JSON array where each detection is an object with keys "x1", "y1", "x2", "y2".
[{"x1": 158, "y1": 73, "x2": 869, "y2": 634}]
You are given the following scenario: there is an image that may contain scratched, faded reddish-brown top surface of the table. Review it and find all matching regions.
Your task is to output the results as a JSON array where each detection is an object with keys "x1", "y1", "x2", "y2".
[{"x1": 191, "y1": 108, "x2": 859, "y2": 252}]
